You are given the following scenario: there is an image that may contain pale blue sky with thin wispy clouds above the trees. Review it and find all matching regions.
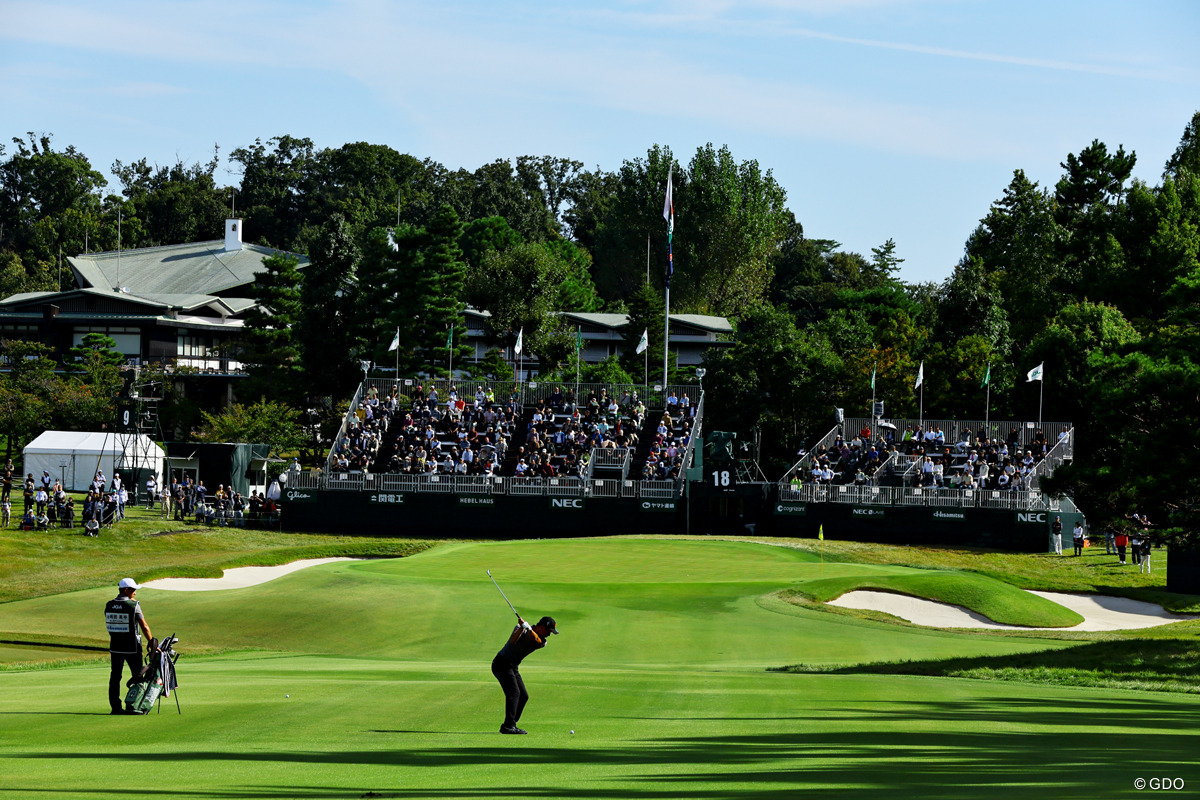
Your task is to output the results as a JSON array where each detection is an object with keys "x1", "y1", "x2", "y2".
[{"x1": 0, "y1": 0, "x2": 1200, "y2": 281}]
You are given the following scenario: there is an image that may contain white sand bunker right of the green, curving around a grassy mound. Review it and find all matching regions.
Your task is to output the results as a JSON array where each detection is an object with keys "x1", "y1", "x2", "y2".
[{"x1": 829, "y1": 590, "x2": 1200, "y2": 631}]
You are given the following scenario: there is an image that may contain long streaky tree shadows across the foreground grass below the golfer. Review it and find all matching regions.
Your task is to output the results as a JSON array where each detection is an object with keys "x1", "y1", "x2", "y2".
[{"x1": 10, "y1": 696, "x2": 1200, "y2": 800}]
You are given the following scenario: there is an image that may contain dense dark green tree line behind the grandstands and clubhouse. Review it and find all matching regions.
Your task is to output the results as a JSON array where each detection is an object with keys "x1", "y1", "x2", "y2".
[{"x1": 0, "y1": 114, "x2": 1200, "y2": 544}]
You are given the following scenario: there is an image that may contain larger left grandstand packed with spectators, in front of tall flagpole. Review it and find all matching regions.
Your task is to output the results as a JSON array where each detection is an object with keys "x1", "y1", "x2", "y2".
[{"x1": 283, "y1": 379, "x2": 703, "y2": 534}]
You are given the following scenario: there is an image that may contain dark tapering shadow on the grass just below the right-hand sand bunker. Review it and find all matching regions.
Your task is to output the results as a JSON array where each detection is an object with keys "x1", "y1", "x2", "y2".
[{"x1": 770, "y1": 638, "x2": 1200, "y2": 693}]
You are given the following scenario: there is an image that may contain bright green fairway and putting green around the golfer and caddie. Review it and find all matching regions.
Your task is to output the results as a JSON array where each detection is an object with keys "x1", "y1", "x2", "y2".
[{"x1": 0, "y1": 539, "x2": 1200, "y2": 799}]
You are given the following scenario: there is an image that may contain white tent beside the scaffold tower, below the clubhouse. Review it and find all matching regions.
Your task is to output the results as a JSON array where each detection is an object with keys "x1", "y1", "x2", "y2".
[{"x1": 24, "y1": 431, "x2": 167, "y2": 492}]
